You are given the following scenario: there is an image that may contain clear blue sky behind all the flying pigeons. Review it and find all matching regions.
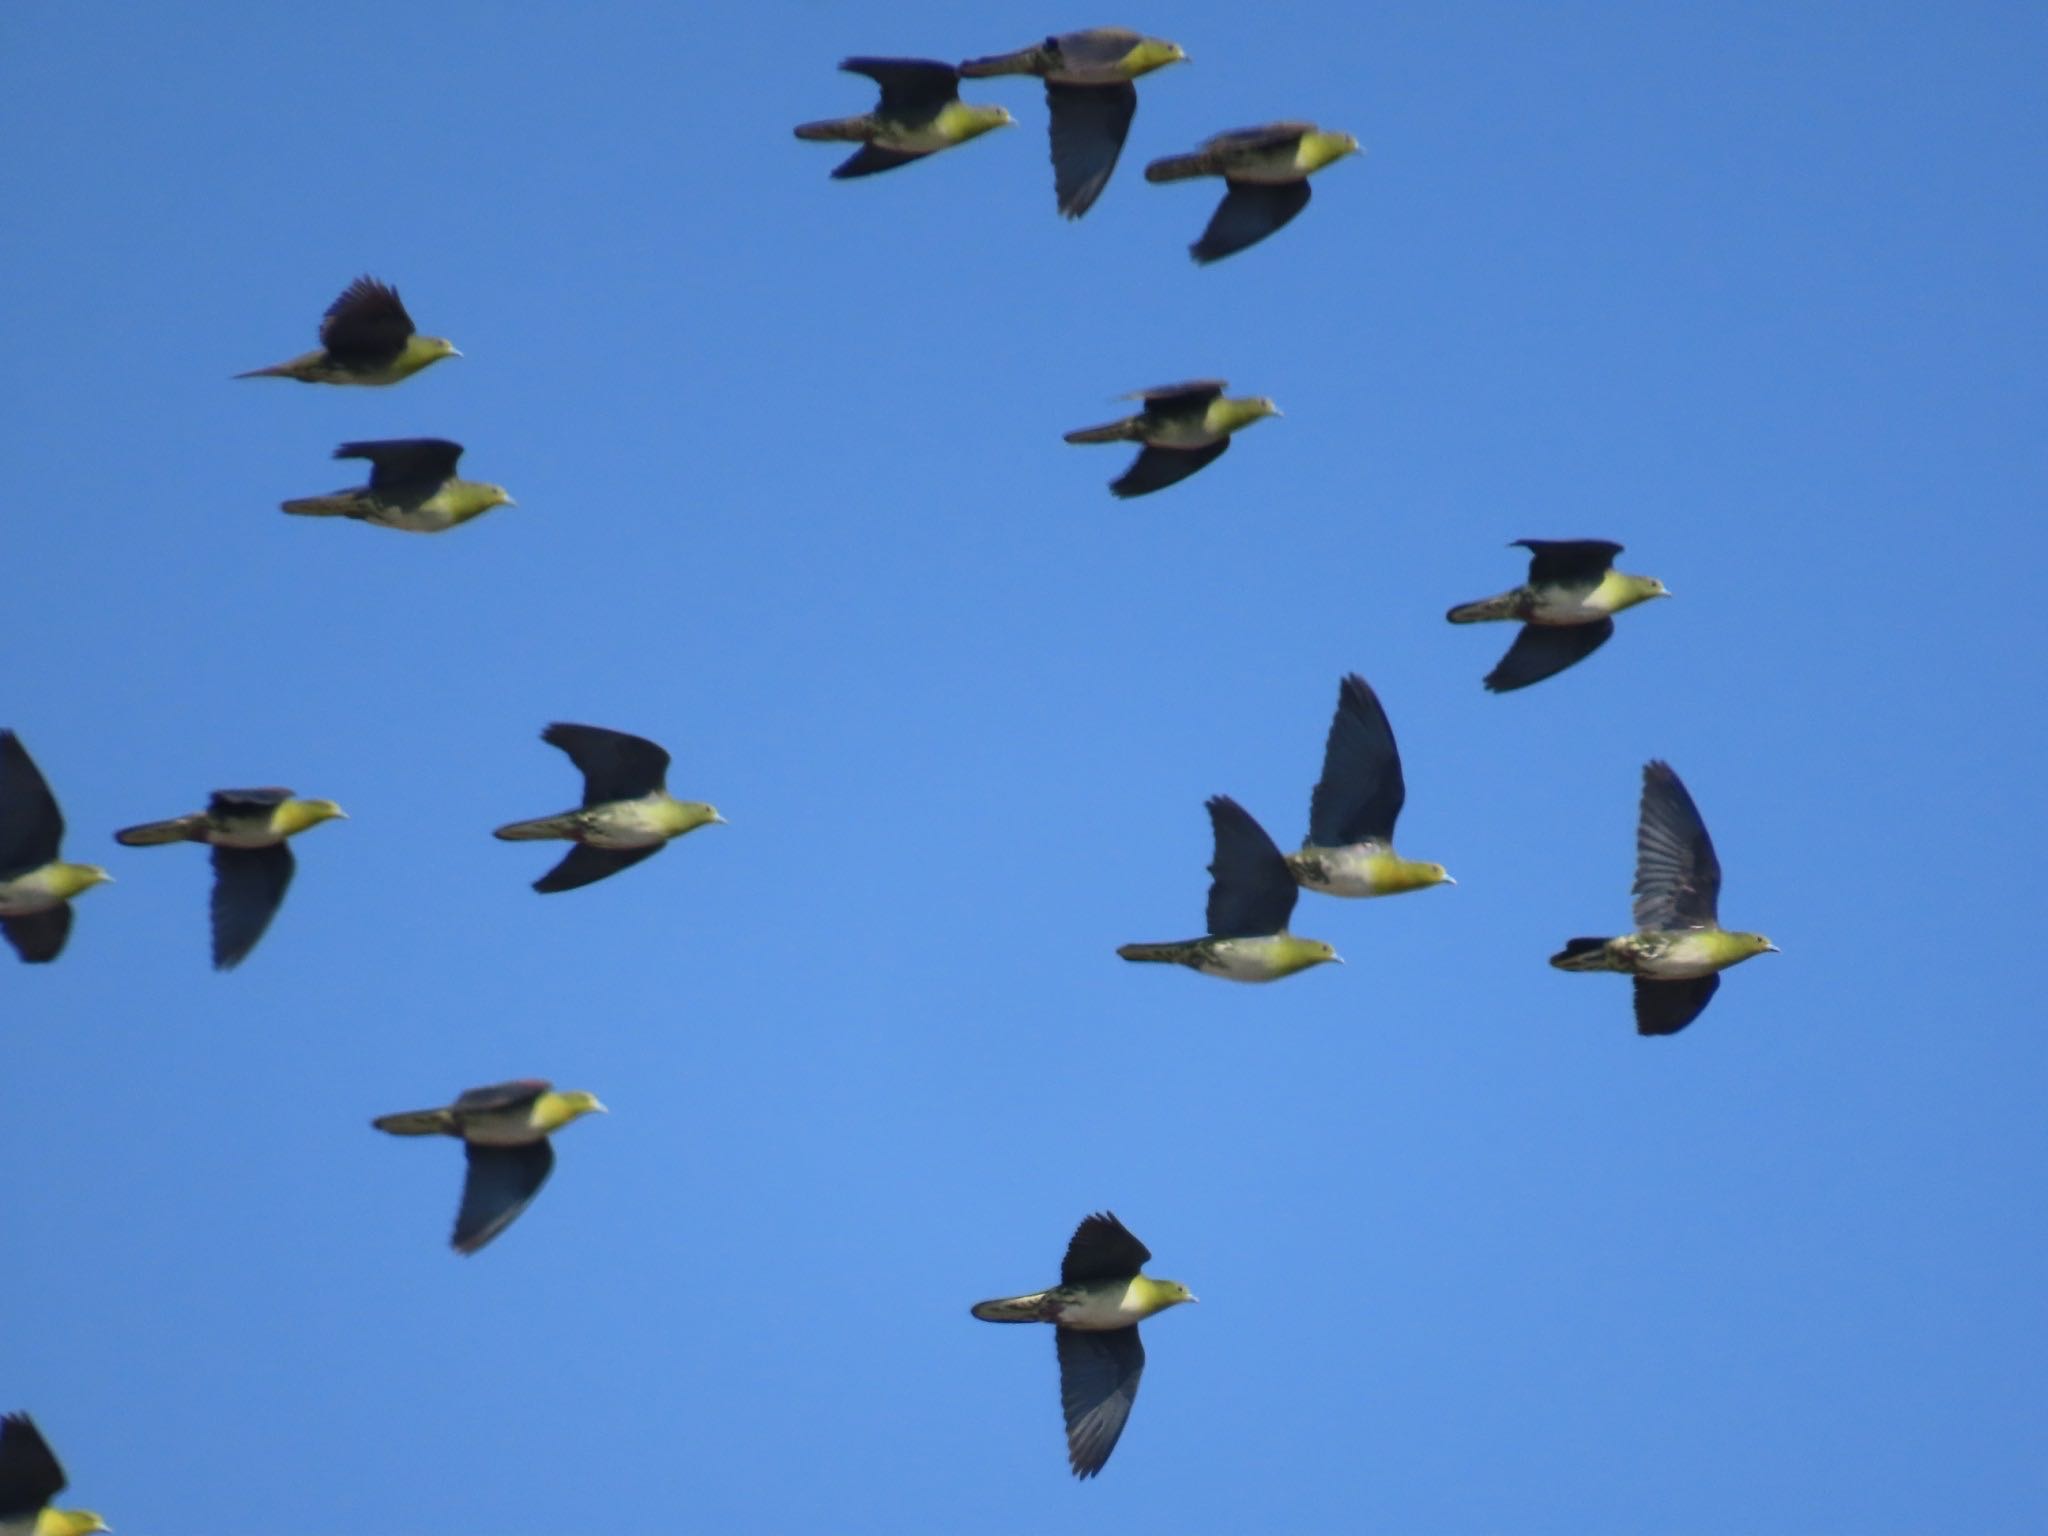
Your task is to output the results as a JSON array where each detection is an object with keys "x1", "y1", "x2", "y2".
[{"x1": 0, "y1": 0, "x2": 2048, "y2": 1536}]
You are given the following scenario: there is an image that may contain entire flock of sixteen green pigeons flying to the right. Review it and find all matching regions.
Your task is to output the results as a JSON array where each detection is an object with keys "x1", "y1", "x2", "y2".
[{"x1": 0, "y1": 27, "x2": 1776, "y2": 1536}]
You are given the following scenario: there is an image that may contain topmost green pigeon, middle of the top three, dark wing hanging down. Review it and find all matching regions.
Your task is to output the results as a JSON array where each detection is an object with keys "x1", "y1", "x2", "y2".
[{"x1": 961, "y1": 27, "x2": 1188, "y2": 219}]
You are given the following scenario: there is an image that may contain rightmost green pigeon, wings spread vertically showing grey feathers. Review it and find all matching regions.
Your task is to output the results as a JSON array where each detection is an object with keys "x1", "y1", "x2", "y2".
[{"x1": 1550, "y1": 762, "x2": 1778, "y2": 1034}]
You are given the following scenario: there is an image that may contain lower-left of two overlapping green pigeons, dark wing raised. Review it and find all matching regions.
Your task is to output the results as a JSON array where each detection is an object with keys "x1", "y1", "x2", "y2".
[{"x1": 1116, "y1": 795, "x2": 1343, "y2": 981}]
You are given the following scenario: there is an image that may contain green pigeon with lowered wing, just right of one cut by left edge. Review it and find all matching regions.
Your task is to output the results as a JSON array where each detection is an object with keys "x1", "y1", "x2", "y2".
[{"x1": 115, "y1": 788, "x2": 348, "y2": 971}]
